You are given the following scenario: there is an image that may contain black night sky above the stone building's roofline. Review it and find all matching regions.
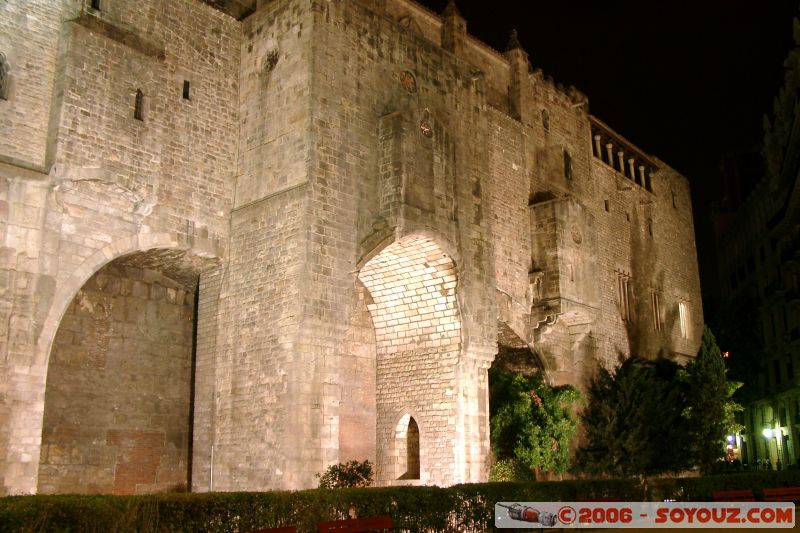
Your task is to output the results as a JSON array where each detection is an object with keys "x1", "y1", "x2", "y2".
[{"x1": 421, "y1": 0, "x2": 798, "y2": 306}]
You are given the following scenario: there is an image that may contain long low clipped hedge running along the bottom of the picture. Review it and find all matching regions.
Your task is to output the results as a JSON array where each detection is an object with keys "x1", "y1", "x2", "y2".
[{"x1": 0, "y1": 470, "x2": 800, "y2": 533}]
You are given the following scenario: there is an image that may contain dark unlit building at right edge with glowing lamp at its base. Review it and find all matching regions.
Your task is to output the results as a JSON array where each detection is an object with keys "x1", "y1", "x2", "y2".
[{"x1": 715, "y1": 20, "x2": 800, "y2": 468}]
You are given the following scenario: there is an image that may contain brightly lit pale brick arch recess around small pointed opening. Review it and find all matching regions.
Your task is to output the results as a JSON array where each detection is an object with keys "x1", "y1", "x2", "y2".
[{"x1": 358, "y1": 232, "x2": 462, "y2": 484}]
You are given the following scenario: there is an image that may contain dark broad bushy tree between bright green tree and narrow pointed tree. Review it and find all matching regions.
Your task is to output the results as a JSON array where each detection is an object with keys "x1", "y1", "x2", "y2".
[{"x1": 578, "y1": 357, "x2": 690, "y2": 476}]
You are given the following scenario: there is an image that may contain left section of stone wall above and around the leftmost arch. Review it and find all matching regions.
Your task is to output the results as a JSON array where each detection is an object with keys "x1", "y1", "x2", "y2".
[{"x1": 0, "y1": 0, "x2": 239, "y2": 493}]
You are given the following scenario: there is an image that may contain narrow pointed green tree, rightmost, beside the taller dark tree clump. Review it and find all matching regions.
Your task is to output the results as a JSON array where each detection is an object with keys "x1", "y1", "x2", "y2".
[{"x1": 686, "y1": 327, "x2": 742, "y2": 472}]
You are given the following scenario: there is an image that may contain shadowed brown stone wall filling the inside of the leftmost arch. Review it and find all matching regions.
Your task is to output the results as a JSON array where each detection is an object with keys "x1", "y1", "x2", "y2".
[{"x1": 39, "y1": 260, "x2": 194, "y2": 494}]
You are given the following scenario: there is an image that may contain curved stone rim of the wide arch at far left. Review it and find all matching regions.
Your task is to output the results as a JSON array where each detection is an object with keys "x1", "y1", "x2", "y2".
[{"x1": 6, "y1": 233, "x2": 219, "y2": 493}]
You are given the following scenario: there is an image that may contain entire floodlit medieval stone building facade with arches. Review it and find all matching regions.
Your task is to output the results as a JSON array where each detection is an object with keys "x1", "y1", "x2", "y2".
[{"x1": 0, "y1": 0, "x2": 703, "y2": 494}]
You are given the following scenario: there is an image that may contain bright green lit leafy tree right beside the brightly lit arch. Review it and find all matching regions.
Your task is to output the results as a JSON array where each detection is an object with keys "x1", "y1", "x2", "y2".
[{"x1": 489, "y1": 369, "x2": 582, "y2": 473}]
